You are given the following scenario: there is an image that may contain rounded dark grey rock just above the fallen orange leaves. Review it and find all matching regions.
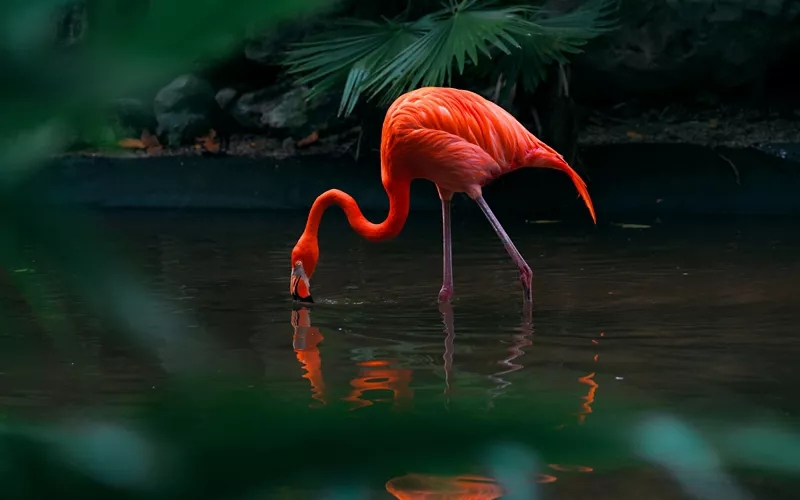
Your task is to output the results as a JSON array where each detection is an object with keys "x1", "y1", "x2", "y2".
[{"x1": 153, "y1": 75, "x2": 219, "y2": 146}]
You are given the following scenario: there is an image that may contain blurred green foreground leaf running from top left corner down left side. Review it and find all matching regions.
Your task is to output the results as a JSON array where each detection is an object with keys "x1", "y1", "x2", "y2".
[{"x1": 0, "y1": 0, "x2": 332, "y2": 371}]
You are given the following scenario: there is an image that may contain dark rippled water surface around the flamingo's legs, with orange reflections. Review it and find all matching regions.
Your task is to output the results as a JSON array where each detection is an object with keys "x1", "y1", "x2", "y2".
[{"x1": 0, "y1": 210, "x2": 800, "y2": 498}]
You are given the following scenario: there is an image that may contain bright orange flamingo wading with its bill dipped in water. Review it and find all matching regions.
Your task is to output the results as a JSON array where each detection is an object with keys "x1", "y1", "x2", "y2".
[{"x1": 289, "y1": 87, "x2": 597, "y2": 304}]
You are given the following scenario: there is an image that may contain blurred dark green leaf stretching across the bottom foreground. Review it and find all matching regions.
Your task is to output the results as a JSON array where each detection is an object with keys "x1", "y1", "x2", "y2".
[{"x1": 0, "y1": 378, "x2": 800, "y2": 500}]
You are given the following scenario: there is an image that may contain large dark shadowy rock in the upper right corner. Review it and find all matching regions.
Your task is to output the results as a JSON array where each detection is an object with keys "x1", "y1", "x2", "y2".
[{"x1": 568, "y1": 0, "x2": 800, "y2": 99}]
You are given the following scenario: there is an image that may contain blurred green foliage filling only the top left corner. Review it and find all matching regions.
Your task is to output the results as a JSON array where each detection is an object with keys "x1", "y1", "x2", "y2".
[{"x1": 0, "y1": 0, "x2": 333, "y2": 166}]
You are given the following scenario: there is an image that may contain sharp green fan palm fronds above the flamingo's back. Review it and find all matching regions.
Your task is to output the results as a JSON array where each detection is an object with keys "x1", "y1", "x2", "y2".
[{"x1": 286, "y1": 0, "x2": 616, "y2": 115}]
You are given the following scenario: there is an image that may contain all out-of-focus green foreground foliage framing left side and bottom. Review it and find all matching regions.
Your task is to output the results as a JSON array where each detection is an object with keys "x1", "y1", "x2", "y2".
[{"x1": 0, "y1": 0, "x2": 800, "y2": 500}]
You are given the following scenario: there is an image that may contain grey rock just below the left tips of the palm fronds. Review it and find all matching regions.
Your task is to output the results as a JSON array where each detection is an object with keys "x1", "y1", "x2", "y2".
[{"x1": 231, "y1": 87, "x2": 309, "y2": 131}]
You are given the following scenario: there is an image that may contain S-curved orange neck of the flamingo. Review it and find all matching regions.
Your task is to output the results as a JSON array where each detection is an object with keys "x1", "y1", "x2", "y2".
[{"x1": 304, "y1": 181, "x2": 411, "y2": 241}]
